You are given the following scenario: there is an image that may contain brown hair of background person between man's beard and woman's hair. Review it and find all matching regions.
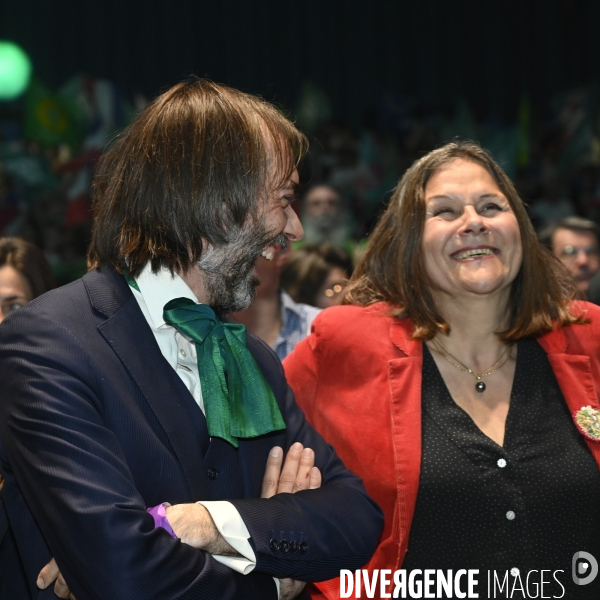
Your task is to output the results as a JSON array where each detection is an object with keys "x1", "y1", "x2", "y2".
[{"x1": 281, "y1": 243, "x2": 352, "y2": 306}]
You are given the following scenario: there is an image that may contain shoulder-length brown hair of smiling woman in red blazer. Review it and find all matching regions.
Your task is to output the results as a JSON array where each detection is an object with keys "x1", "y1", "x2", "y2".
[{"x1": 343, "y1": 141, "x2": 585, "y2": 342}]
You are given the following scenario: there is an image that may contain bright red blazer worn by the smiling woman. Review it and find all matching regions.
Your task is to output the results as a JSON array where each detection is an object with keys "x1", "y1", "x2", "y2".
[{"x1": 284, "y1": 302, "x2": 600, "y2": 598}]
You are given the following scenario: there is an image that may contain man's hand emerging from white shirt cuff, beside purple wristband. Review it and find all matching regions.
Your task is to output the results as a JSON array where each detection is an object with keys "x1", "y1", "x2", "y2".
[{"x1": 166, "y1": 504, "x2": 240, "y2": 556}]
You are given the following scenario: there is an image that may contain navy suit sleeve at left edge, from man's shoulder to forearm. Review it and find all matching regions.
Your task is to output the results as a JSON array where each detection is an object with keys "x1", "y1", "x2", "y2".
[{"x1": 0, "y1": 309, "x2": 277, "y2": 600}]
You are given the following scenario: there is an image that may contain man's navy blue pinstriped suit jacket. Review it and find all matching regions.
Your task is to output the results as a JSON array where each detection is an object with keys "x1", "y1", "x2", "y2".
[{"x1": 0, "y1": 268, "x2": 382, "y2": 600}]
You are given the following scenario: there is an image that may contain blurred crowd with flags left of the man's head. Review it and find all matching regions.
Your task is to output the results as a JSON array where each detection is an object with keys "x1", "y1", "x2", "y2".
[{"x1": 0, "y1": 77, "x2": 138, "y2": 285}]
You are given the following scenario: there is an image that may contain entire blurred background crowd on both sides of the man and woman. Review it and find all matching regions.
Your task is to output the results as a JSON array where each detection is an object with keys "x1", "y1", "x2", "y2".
[{"x1": 0, "y1": 77, "x2": 600, "y2": 306}]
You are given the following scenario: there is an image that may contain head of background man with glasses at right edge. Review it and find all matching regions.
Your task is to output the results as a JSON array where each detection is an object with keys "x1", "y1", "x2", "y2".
[{"x1": 540, "y1": 217, "x2": 600, "y2": 299}]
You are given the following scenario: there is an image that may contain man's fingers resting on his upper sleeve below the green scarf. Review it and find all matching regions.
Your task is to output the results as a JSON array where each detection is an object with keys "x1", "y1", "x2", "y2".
[{"x1": 260, "y1": 442, "x2": 321, "y2": 498}]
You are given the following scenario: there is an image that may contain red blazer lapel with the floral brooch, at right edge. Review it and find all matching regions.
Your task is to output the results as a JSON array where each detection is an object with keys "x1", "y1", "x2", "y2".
[{"x1": 538, "y1": 329, "x2": 600, "y2": 467}]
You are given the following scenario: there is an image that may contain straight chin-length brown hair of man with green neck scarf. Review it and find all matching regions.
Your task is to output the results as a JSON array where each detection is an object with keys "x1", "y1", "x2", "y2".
[{"x1": 88, "y1": 80, "x2": 307, "y2": 277}]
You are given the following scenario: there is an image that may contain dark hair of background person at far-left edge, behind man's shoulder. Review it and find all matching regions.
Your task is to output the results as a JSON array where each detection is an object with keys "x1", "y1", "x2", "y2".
[{"x1": 0, "y1": 238, "x2": 56, "y2": 300}]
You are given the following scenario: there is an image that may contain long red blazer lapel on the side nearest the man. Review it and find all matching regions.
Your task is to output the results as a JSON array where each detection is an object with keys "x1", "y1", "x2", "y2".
[{"x1": 388, "y1": 319, "x2": 423, "y2": 564}]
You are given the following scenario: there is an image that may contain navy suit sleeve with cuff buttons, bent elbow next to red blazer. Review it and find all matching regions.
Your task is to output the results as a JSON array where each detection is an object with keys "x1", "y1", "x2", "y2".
[{"x1": 231, "y1": 332, "x2": 383, "y2": 581}]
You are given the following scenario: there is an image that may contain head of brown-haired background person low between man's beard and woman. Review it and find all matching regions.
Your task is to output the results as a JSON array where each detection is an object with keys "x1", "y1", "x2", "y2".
[{"x1": 281, "y1": 243, "x2": 352, "y2": 308}]
